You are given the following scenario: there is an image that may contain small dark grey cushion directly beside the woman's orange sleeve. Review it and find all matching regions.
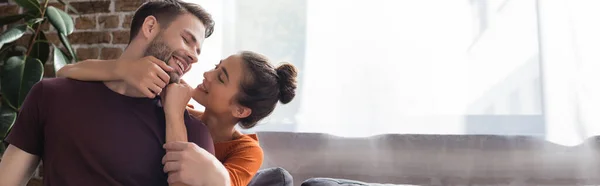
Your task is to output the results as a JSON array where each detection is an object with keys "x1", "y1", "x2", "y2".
[{"x1": 248, "y1": 167, "x2": 293, "y2": 186}]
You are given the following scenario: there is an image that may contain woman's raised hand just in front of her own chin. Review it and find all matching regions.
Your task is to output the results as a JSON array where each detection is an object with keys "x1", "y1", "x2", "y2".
[{"x1": 163, "y1": 83, "x2": 193, "y2": 116}]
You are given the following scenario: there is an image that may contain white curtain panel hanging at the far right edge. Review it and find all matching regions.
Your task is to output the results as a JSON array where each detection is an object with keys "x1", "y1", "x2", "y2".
[{"x1": 540, "y1": 0, "x2": 600, "y2": 145}]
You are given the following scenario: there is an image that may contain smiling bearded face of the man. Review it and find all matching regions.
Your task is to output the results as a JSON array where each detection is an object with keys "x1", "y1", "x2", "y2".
[{"x1": 144, "y1": 13, "x2": 206, "y2": 83}]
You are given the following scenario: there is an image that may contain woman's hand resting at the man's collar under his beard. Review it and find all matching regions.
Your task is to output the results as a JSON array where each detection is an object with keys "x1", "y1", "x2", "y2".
[{"x1": 115, "y1": 56, "x2": 174, "y2": 98}]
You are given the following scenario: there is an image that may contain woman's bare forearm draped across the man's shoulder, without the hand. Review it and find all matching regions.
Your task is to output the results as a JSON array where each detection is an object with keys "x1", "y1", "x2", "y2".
[{"x1": 56, "y1": 59, "x2": 121, "y2": 81}]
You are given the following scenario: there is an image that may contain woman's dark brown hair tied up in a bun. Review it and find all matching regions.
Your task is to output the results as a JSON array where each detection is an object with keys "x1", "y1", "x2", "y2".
[{"x1": 236, "y1": 51, "x2": 298, "y2": 129}]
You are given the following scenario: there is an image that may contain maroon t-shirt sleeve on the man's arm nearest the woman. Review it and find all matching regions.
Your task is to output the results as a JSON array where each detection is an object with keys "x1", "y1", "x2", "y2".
[{"x1": 184, "y1": 111, "x2": 215, "y2": 155}]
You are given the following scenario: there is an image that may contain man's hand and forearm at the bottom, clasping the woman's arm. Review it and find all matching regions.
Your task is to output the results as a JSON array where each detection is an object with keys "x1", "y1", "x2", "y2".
[{"x1": 162, "y1": 142, "x2": 231, "y2": 186}]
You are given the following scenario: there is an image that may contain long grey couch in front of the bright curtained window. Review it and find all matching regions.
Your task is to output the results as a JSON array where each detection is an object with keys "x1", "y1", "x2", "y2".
[{"x1": 258, "y1": 132, "x2": 600, "y2": 185}]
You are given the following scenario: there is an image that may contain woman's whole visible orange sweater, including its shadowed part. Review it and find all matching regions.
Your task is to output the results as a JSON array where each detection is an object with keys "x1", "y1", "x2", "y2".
[{"x1": 215, "y1": 134, "x2": 263, "y2": 186}]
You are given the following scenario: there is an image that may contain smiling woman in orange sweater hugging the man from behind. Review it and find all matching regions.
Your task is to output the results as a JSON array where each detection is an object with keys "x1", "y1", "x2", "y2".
[{"x1": 58, "y1": 51, "x2": 297, "y2": 186}]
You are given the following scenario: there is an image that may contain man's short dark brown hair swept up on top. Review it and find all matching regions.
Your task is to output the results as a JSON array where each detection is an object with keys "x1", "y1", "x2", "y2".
[{"x1": 129, "y1": 0, "x2": 215, "y2": 43}]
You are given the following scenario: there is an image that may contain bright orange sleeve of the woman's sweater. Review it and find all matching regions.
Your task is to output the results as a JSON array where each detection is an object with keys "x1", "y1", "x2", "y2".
[{"x1": 223, "y1": 143, "x2": 263, "y2": 186}]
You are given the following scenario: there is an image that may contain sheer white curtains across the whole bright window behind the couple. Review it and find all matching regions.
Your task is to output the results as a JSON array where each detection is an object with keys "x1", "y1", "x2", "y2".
[{"x1": 184, "y1": 0, "x2": 600, "y2": 147}]
